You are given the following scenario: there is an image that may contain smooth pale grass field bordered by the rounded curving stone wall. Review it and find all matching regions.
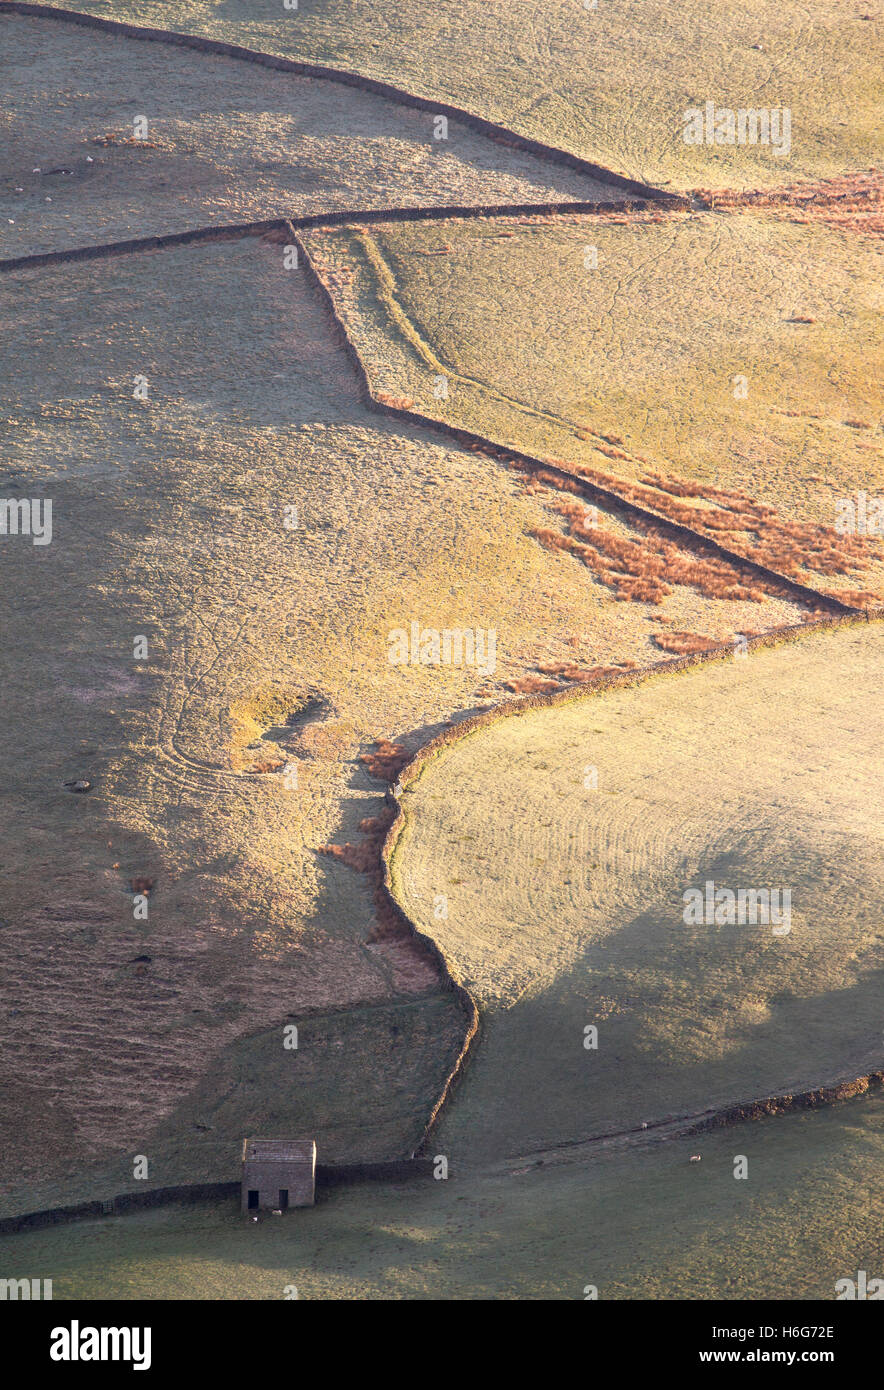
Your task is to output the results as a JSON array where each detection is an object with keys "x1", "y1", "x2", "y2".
[{"x1": 391, "y1": 624, "x2": 884, "y2": 1162}]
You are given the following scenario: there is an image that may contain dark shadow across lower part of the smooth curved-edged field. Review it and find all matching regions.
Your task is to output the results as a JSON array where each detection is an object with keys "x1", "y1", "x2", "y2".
[{"x1": 439, "y1": 834, "x2": 884, "y2": 1161}]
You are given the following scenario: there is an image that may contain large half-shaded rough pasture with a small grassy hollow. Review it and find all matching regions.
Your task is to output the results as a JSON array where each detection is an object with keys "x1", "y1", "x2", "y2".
[{"x1": 0, "y1": 222, "x2": 801, "y2": 1209}]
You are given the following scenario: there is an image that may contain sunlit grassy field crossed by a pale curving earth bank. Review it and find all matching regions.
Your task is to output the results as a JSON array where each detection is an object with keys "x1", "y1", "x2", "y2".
[{"x1": 307, "y1": 202, "x2": 884, "y2": 608}]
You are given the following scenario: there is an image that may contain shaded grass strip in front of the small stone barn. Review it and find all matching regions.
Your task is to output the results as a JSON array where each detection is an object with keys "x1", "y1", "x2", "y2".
[{"x1": 0, "y1": 1095, "x2": 884, "y2": 1300}]
